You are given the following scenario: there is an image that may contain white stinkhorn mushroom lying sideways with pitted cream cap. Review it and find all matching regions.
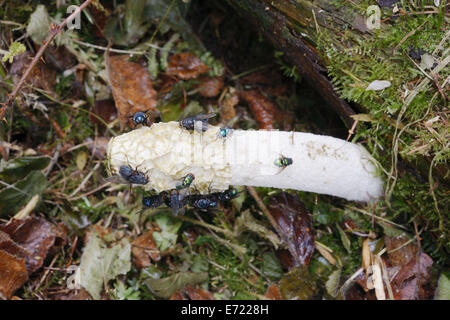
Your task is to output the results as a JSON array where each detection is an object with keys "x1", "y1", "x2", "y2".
[{"x1": 108, "y1": 122, "x2": 383, "y2": 201}]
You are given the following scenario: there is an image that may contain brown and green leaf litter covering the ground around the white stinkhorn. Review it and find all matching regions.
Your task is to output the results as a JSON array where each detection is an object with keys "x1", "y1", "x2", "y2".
[{"x1": 0, "y1": 0, "x2": 442, "y2": 300}]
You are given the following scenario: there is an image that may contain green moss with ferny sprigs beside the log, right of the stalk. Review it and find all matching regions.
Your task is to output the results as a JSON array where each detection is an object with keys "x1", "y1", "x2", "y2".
[{"x1": 312, "y1": 1, "x2": 450, "y2": 263}]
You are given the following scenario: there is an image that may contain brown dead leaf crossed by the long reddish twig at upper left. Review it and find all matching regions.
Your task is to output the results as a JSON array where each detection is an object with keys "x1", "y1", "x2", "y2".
[{"x1": 9, "y1": 51, "x2": 56, "y2": 92}]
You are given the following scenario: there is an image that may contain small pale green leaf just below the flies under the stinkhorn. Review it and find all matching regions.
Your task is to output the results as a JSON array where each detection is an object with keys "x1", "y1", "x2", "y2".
[{"x1": 153, "y1": 214, "x2": 183, "y2": 251}]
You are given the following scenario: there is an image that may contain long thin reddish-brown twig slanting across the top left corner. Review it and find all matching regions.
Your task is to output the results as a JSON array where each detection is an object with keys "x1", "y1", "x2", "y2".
[{"x1": 0, "y1": 0, "x2": 92, "y2": 120}]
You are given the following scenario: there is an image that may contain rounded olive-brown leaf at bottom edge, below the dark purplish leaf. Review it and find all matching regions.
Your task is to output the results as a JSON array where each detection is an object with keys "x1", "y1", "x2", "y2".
[{"x1": 279, "y1": 265, "x2": 319, "y2": 300}]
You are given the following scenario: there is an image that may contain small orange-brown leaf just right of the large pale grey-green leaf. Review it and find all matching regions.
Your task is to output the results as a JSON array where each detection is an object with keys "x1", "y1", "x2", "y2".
[{"x1": 131, "y1": 230, "x2": 161, "y2": 269}]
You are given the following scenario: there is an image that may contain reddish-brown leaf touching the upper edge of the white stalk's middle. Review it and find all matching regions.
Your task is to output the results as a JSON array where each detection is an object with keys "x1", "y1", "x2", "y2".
[{"x1": 239, "y1": 90, "x2": 282, "y2": 130}]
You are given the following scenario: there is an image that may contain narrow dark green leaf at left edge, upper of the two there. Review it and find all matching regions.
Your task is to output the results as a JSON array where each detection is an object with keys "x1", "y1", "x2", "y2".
[{"x1": 0, "y1": 157, "x2": 50, "y2": 183}]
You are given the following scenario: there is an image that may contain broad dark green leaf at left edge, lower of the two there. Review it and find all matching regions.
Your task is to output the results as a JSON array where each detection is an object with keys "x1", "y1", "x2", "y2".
[{"x1": 0, "y1": 171, "x2": 47, "y2": 217}]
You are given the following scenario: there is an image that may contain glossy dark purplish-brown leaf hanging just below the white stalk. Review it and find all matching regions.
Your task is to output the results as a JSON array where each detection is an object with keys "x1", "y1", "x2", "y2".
[{"x1": 269, "y1": 192, "x2": 315, "y2": 266}]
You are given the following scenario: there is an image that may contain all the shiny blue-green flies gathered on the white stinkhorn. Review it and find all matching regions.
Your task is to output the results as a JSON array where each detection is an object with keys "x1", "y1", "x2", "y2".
[{"x1": 114, "y1": 112, "x2": 293, "y2": 215}]
